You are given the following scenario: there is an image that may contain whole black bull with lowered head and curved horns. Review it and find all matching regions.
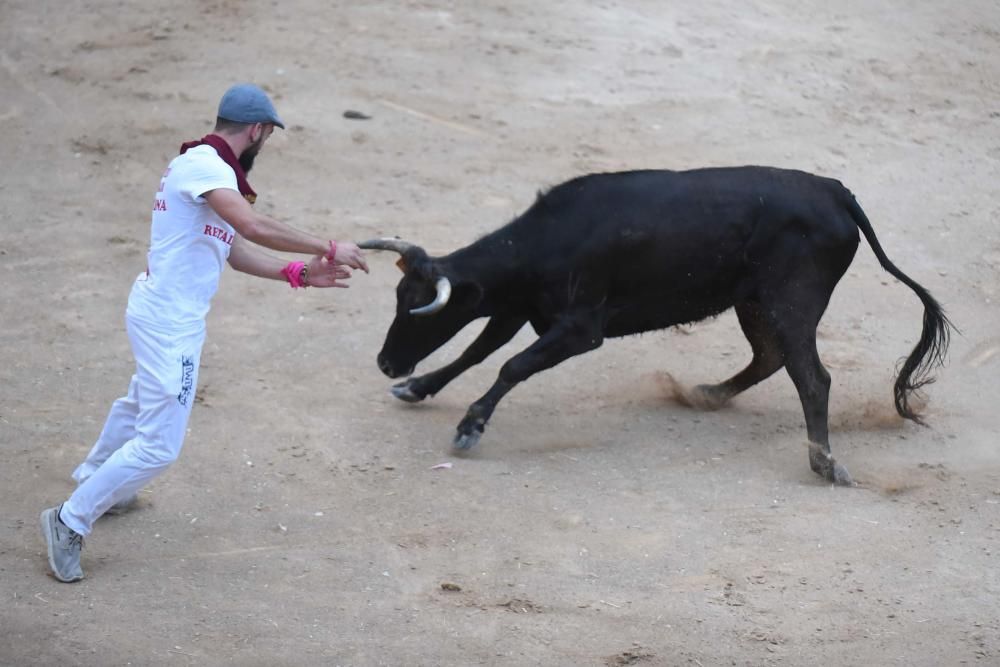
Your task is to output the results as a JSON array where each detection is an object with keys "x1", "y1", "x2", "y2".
[{"x1": 361, "y1": 167, "x2": 951, "y2": 484}]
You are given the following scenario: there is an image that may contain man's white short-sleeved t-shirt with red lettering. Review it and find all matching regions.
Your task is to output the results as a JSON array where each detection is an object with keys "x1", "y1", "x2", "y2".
[{"x1": 128, "y1": 145, "x2": 239, "y2": 329}]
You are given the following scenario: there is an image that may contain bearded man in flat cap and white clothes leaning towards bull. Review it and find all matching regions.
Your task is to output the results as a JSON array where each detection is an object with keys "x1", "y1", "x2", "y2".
[{"x1": 41, "y1": 84, "x2": 368, "y2": 582}]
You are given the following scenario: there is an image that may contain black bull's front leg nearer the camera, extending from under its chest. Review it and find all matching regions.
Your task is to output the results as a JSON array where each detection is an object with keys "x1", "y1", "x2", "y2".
[{"x1": 453, "y1": 311, "x2": 604, "y2": 450}]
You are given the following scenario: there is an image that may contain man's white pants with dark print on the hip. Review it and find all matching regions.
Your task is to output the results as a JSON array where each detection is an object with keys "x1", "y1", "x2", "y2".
[{"x1": 60, "y1": 315, "x2": 205, "y2": 536}]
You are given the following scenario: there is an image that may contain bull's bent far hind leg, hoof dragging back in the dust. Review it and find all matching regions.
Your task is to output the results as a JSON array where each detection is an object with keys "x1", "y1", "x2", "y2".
[{"x1": 687, "y1": 302, "x2": 784, "y2": 410}]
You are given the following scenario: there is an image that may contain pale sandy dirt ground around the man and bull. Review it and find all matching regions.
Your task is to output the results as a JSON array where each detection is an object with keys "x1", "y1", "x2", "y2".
[{"x1": 0, "y1": 0, "x2": 1000, "y2": 666}]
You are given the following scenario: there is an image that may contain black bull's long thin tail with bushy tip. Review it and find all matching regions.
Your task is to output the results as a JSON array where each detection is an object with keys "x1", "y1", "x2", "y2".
[{"x1": 847, "y1": 193, "x2": 954, "y2": 424}]
